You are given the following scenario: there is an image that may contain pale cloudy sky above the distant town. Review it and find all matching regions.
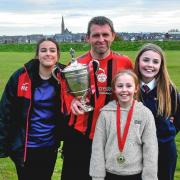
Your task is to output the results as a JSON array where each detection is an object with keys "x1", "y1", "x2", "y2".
[{"x1": 0, "y1": 0, "x2": 180, "y2": 36}]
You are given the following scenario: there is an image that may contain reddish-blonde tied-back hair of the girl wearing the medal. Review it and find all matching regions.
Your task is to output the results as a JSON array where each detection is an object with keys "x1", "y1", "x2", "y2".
[{"x1": 111, "y1": 69, "x2": 140, "y2": 100}]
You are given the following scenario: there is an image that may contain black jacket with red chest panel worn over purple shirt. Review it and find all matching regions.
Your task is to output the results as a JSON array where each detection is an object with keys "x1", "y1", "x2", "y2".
[{"x1": 0, "y1": 59, "x2": 64, "y2": 161}]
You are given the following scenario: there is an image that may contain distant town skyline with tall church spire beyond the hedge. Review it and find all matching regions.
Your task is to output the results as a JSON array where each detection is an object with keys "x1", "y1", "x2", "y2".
[{"x1": 0, "y1": 16, "x2": 180, "y2": 44}]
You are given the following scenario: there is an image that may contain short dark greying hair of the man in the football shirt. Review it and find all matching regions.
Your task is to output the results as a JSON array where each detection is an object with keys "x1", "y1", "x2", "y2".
[{"x1": 87, "y1": 16, "x2": 115, "y2": 36}]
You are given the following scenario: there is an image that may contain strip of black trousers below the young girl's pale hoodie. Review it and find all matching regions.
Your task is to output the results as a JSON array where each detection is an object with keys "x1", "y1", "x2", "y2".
[{"x1": 105, "y1": 172, "x2": 142, "y2": 180}]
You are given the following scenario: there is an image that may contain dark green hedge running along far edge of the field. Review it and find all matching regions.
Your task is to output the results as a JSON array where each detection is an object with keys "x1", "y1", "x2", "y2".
[{"x1": 0, "y1": 41, "x2": 180, "y2": 52}]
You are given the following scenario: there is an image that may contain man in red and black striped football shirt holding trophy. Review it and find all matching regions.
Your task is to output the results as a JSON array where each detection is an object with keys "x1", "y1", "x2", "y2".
[{"x1": 61, "y1": 16, "x2": 132, "y2": 180}]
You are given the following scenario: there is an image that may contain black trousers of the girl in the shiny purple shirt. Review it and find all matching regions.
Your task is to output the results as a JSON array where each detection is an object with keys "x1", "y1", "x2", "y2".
[{"x1": 11, "y1": 147, "x2": 57, "y2": 180}]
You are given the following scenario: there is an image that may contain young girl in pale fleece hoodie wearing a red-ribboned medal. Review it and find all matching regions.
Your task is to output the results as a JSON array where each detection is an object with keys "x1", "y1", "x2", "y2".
[{"x1": 90, "y1": 70, "x2": 158, "y2": 180}]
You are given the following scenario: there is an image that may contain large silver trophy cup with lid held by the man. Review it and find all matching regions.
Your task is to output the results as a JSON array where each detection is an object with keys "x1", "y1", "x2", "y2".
[{"x1": 52, "y1": 48, "x2": 99, "y2": 112}]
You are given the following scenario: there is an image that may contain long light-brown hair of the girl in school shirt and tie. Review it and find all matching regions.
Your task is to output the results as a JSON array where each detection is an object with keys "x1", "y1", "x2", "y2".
[{"x1": 135, "y1": 43, "x2": 176, "y2": 117}]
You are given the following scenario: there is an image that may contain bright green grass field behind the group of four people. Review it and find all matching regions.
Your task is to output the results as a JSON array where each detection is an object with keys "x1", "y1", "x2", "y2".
[{"x1": 0, "y1": 51, "x2": 180, "y2": 180}]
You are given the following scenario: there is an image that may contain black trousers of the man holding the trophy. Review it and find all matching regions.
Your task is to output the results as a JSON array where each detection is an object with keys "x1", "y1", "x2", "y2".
[{"x1": 61, "y1": 130, "x2": 92, "y2": 180}]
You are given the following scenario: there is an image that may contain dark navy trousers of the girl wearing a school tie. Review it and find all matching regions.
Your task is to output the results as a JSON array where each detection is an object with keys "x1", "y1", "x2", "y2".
[{"x1": 158, "y1": 140, "x2": 177, "y2": 180}]
